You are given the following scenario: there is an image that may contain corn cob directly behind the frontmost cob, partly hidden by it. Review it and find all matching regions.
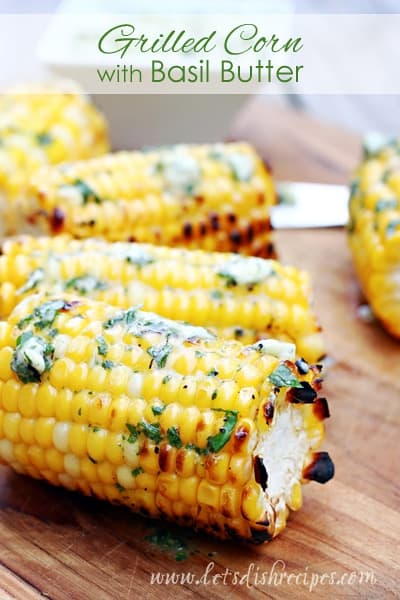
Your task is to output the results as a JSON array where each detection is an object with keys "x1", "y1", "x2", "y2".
[{"x1": 0, "y1": 236, "x2": 324, "y2": 362}]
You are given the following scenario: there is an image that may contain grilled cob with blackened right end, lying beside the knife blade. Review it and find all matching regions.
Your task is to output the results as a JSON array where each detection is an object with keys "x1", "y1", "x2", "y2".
[{"x1": 21, "y1": 143, "x2": 275, "y2": 257}]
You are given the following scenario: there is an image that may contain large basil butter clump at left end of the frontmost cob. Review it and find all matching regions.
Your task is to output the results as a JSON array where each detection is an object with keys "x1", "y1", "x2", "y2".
[{"x1": 11, "y1": 331, "x2": 54, "y2": 383}]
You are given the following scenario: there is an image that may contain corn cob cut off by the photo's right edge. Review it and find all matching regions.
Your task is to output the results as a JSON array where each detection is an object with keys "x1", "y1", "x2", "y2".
[{"x1": 348, "y1": 141, "x2": 400, "y2": 337}]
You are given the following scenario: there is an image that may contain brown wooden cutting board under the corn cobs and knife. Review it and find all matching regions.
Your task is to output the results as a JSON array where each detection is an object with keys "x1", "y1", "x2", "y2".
[{"x1": 0, "y1": 100, "x2": 400, "y2": 600}]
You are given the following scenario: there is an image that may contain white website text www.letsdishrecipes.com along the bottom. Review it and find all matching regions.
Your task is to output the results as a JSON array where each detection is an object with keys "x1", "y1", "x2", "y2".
[{"x1": 150, "y1": 560, "x2": 377, "y2": 592}]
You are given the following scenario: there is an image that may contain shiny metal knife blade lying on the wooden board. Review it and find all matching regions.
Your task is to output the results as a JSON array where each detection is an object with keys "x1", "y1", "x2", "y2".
[{"x1": 271, "y1": 182, "x2": 349, "y2": 229}]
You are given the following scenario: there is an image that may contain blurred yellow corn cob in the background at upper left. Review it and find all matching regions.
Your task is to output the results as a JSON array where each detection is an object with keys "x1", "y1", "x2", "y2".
[{"x1": 0, "y1": 83, "x2": 109, "y2": 235}]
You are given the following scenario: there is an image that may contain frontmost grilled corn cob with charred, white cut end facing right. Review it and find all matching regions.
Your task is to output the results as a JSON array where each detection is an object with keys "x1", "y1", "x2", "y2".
[{"x1": 0, "y1": 294, "x2": 333, "y2": 542}]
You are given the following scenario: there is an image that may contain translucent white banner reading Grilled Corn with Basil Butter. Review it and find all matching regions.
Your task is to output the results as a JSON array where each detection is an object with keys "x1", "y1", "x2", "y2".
[{"x1": 0, "y1": 13, "x2": 400, "y2": 94}]
